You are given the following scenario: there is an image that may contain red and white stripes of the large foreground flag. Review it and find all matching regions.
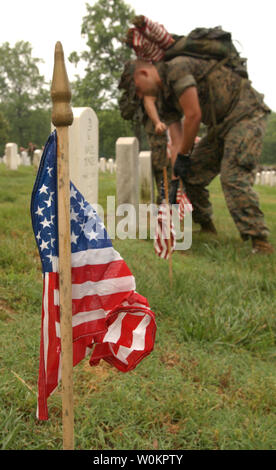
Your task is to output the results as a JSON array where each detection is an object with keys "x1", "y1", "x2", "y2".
[{"x1": 37, "y1": 247, "x2": 156, "y2": 420}]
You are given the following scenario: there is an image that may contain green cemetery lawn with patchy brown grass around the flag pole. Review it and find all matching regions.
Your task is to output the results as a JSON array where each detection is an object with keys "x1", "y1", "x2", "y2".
[{"x1": 0, "y1": 164, "x2": 276, "y2": 450}]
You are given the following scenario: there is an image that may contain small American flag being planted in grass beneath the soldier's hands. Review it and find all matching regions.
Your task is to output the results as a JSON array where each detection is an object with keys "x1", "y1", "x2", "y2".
[{"x1": 154, "y1": 181, "x2": 176, "y2": 259}]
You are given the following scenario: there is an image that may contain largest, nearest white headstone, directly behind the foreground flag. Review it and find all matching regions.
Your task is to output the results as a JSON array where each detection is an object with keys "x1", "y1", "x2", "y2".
[{"x1": 69, "y1": 107, "x2": 99, "y2": 204}]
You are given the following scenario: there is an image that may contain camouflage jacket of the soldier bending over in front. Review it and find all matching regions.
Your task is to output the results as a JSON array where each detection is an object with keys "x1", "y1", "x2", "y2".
[{"x1": 155, "y1": 56, "x2": 270, "y2": 136}]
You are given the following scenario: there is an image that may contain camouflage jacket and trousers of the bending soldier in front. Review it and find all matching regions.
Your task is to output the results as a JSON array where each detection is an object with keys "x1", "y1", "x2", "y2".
[{"x1": 156, "y1": 57, "x2": 270, "y2": 239}]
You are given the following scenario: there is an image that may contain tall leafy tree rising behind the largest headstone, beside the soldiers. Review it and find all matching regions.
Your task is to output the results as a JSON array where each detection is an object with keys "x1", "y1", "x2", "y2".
[{"x1": 69, "y1": 0, "x2": 135, "y2": 112}]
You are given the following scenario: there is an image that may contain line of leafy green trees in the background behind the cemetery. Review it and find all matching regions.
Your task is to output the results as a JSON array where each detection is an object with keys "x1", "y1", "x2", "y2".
[{"x1": 0, "y1": 0, "x2": 276, "y2": 164}]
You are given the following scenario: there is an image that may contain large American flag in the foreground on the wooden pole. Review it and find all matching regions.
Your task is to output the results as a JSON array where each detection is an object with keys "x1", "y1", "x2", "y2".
[{"x1": 31, "y1": 131, "x2": 156, "y2": 420}]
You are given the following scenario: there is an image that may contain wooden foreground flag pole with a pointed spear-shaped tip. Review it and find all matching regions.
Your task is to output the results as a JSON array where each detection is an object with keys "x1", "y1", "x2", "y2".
[{"x1": 51, "y1": 42, "x2": 74, "y2": 450}]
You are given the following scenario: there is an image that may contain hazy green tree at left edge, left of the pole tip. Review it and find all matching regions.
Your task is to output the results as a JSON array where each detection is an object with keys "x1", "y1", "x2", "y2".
[{"x1": 0, "y1": 41, "x2": 50, "y2": 146}]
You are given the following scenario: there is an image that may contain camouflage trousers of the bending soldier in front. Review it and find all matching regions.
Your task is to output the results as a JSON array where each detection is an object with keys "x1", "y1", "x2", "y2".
[{"x1": 186, "y1": 115, "x2": 269, "y2": 240}]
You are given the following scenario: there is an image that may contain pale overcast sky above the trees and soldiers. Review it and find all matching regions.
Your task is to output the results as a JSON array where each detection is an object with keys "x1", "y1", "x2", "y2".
[{"x1": 0, "y1": 0, "x2": 276, "y2": 111}]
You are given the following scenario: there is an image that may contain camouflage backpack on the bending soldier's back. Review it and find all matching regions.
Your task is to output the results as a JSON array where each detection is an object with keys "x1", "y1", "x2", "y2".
[{"x1": 163, "y1": 26, "x2": 248, "y2": 78}]
